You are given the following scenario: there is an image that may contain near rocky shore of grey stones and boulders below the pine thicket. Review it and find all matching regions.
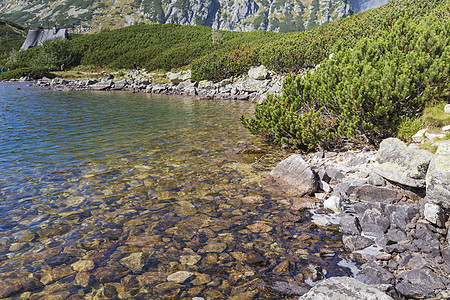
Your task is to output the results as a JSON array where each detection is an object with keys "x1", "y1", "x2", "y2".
[{"x1": 271, "y1": 138, "x2": 450, "y2": 299}]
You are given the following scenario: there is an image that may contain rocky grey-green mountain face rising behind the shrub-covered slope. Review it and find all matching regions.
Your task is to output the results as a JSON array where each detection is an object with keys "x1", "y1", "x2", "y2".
[{"x1": 0, "y1": 0, "x2": 387, "y2": 32}]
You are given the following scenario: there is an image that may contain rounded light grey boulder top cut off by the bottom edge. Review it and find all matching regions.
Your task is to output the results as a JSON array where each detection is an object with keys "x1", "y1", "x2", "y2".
[{"x1": 298, "y1": 277, "x2": 393, "y2": 300}]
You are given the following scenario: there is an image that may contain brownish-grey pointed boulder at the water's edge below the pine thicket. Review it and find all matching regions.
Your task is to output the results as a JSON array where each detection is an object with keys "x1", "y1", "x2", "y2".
[{"x1": 270, "y1": 154, "x2": 317, "y2": 196}]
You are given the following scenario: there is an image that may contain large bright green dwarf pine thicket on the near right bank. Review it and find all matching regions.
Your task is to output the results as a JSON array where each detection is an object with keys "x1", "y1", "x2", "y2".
[{"x1": 242, "y1": 0, "x2": 450, "y2": 150}]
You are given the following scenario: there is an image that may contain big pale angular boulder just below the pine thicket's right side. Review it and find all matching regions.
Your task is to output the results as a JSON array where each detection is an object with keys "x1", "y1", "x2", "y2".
[{"x1": 374, "y1": 138, "x2": 433, "y2": 188}]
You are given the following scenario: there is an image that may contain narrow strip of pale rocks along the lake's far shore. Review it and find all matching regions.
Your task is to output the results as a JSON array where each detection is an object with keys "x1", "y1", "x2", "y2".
[{"x1": 20, "y1": 66, "x2": 284, "y2": 103}]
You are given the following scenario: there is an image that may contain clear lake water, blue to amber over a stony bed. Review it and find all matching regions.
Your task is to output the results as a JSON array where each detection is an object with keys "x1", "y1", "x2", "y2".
[{"x1": 0, "y1": 83, "x2": 350, "y2": 299}]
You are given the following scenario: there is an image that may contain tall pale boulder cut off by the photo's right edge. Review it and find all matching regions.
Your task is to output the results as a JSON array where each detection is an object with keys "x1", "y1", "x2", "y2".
[{"x1": 426, "y1": 142, "x2": 450, "y2": 209}]
